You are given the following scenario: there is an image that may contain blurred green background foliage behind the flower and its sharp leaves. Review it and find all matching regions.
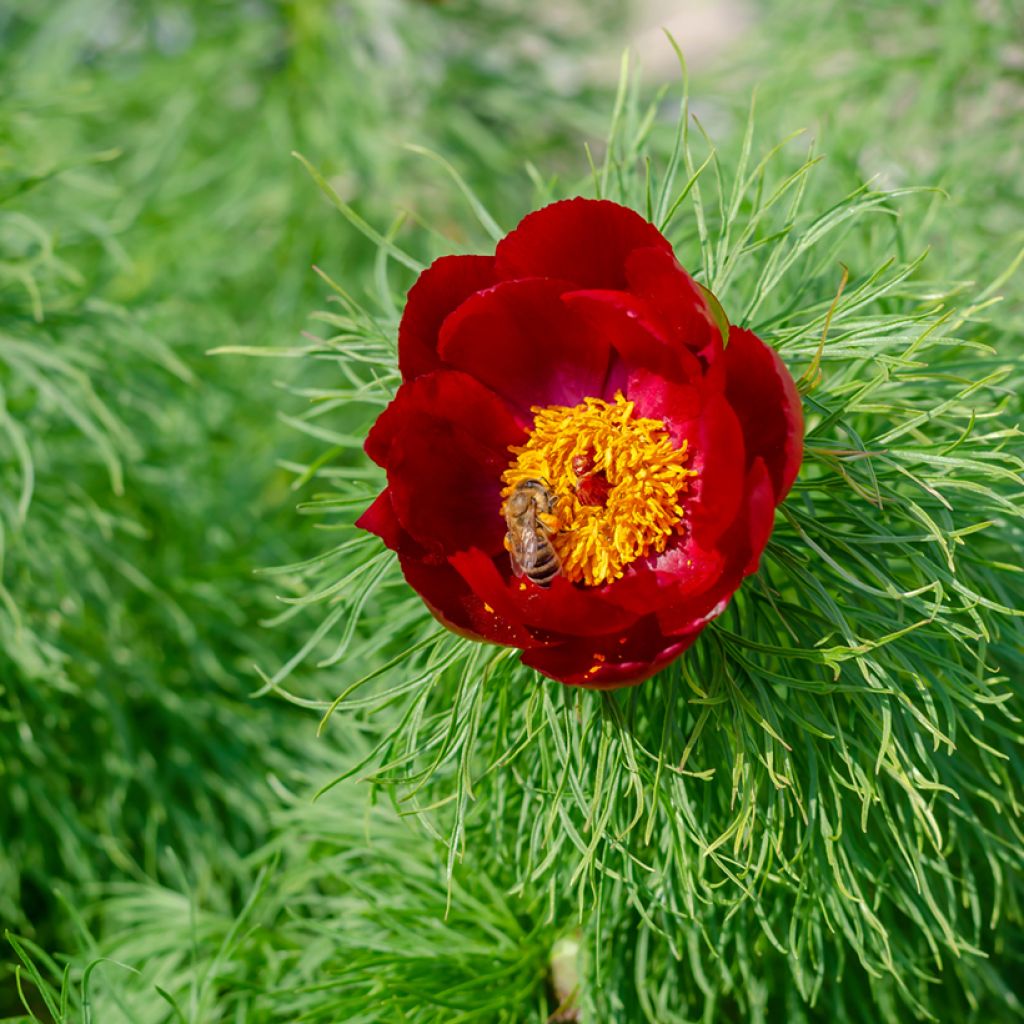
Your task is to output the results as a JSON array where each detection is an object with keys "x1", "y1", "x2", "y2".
[{"x1": 0, "y1": 0, "x2": 1024, "y2": 1024}]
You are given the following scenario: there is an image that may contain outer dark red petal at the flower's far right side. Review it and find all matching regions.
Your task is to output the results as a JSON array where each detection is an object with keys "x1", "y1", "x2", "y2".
[{"x1": 725, "y1": 328, "x2": 804, "y2": 504}]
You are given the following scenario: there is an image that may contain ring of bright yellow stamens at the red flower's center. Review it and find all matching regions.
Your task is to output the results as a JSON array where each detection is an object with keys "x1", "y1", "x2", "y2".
[{"x1": 502, "y1": 392, "x2": 696, "y2": 587}]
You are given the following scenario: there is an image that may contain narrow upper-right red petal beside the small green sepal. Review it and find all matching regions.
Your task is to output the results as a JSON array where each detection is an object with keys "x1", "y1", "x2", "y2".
[{"x1": 626, "y1": 248, "x2": 724, "y2": 364}]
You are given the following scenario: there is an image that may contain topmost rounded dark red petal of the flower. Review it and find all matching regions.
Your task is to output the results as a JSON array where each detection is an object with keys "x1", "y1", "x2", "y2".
[{"x1": 495, "y1": 199, "x2": 672, "y2": 289}]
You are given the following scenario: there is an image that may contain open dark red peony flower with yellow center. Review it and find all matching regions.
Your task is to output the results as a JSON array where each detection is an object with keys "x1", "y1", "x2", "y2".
[{"x1": 358, "y1": 199, "x2": 803, "y2": 688}]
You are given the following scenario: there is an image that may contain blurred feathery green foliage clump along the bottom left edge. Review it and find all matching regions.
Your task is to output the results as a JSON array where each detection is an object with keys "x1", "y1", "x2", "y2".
[{"x1": 6, "y1": 788, "x2": 558, "y2": 1024}]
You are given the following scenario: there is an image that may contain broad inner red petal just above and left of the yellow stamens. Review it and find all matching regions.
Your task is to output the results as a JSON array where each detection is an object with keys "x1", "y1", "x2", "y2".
[{"x1": 439, "y1": 279, "x2": 609, "y2": 413}]
